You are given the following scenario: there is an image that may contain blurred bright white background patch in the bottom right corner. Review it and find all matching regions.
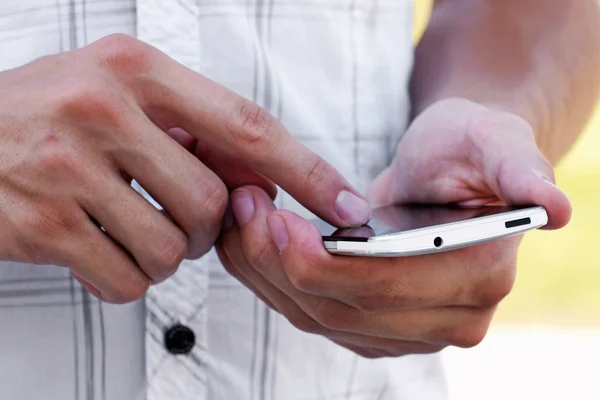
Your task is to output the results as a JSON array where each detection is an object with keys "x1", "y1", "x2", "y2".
[{"x1": 442, "y1": 326, "x2": 600, "y2": 400}]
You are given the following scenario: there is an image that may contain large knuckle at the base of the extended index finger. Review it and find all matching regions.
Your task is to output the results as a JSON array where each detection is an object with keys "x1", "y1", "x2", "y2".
[{"x1": 94, "y1": 33, "x2": 155, "y2": 76}]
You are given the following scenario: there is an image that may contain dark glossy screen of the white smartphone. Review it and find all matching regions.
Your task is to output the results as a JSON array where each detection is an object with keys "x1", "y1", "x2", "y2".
[{"x1": 315, "y1": 205, "x2": 527, "y2": 242}]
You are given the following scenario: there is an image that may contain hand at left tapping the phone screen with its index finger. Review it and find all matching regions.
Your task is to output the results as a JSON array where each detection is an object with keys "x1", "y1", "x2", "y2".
[{"x1": 0, "y1": 35, "x2": 370, "y2": 303}]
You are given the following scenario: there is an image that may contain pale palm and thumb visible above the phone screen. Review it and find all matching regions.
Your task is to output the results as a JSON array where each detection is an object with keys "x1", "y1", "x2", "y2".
[{"x1": 368, "y1": 99, "x2": 571, "y2": 228}]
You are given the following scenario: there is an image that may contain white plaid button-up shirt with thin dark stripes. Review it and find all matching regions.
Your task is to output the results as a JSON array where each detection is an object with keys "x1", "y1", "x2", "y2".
[{"x1": 0, "y1": 0, "x2": 445, "y2": 400}]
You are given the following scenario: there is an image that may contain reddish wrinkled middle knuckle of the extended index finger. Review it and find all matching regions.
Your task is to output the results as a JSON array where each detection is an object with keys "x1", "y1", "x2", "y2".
[{"x1": 233, "y1": 100, "x2": 275, "y2": 151}]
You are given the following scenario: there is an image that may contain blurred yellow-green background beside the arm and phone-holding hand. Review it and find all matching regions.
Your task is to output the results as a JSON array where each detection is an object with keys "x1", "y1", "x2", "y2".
[{"x1": 415, "y1": 0, "x2": 600, "y2": 326}]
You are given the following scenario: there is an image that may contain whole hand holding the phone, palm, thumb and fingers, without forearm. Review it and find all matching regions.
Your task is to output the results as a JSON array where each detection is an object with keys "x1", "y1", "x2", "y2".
[{"x1": 217, "y1": 99, "x2": 571, "y2": 357}]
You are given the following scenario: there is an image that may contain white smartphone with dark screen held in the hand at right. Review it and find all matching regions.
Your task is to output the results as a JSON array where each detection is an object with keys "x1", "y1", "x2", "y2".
[{"x1": 316, "y1": 205, "x2": 548, "y2": 257}]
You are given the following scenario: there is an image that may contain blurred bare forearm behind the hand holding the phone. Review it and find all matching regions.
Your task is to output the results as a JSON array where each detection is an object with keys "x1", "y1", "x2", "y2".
[{"x1": 411, "y1": 0, "x2": 600, "y2": 164}]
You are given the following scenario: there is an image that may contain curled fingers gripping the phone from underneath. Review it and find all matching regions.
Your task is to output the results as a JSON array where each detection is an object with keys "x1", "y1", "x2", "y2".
[{"x1": 216, "y1": 186, "x2": 519, "y2": 358}]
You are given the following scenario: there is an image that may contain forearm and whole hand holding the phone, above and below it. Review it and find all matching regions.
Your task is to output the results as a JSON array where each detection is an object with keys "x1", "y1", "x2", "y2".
[{"x1": 217, "y1": 0, "x2": 600, "y2": 358}]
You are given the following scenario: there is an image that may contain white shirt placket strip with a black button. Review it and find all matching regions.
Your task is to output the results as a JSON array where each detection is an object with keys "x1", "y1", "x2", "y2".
[{"x1": 136, "y1": 0, "x2": 209, "y2": 400}]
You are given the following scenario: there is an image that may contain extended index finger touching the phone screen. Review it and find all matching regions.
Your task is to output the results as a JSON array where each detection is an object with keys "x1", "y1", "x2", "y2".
[{"x1": 140, "y1": 46, "x2": 371, "y2": 227}]
